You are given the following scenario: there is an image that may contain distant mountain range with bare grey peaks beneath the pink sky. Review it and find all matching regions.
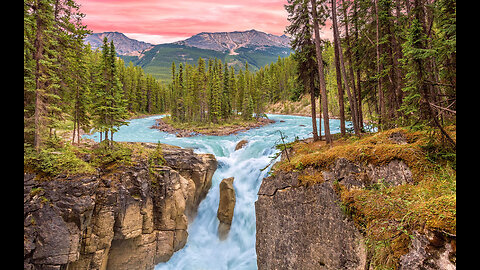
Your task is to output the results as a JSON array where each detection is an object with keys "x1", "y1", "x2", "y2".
[{"x1": 85, "y1": 29, "x2": 291, "y2": 81}]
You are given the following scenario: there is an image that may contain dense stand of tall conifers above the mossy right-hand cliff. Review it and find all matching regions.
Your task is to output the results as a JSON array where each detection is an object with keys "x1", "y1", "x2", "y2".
[{"x1": 286, "y1": 0, "x2": 456, "y2": 148}]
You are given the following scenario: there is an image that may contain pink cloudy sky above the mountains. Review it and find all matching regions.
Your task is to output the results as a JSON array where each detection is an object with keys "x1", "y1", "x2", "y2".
[{"x1": 77, "y1": 0, "x2": 331, "y2": 44}]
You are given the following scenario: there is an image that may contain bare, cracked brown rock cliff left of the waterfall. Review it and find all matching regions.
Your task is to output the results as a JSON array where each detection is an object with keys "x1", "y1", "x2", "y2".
[{"x1": 24, "y1": 143, "x2": 217, "y2": 269}]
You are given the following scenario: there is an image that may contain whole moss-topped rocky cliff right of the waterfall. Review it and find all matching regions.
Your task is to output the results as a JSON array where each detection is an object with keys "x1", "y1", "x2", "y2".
[{"x1": 255, "y1": 131, "x2": 456, "y2": 270}]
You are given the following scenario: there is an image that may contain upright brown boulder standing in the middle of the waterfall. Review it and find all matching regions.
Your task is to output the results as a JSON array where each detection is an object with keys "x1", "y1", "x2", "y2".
[{"x1": 217, "y1": 177, "x2": 236, "y2": 240}]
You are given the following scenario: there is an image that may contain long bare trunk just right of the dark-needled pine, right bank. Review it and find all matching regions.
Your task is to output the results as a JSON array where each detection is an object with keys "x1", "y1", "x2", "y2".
[{"x1": 310, "y1": 0, "x2": 332, "y2": 144}]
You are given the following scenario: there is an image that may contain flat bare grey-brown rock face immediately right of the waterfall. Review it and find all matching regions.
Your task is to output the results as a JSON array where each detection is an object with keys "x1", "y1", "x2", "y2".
[{"x1": 255, "y1": 172, "x2": 366, "y2": 270}]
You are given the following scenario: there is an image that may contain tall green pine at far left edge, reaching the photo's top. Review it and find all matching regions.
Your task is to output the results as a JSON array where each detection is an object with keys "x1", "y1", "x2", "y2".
[{"x1": 24, "y1": 0, "x2": 87, "y2": 151}]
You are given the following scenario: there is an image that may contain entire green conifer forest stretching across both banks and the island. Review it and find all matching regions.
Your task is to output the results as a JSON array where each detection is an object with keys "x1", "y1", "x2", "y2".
[{"x1": 24, "y1": 0, "x2": 456, "y2": 151}]
